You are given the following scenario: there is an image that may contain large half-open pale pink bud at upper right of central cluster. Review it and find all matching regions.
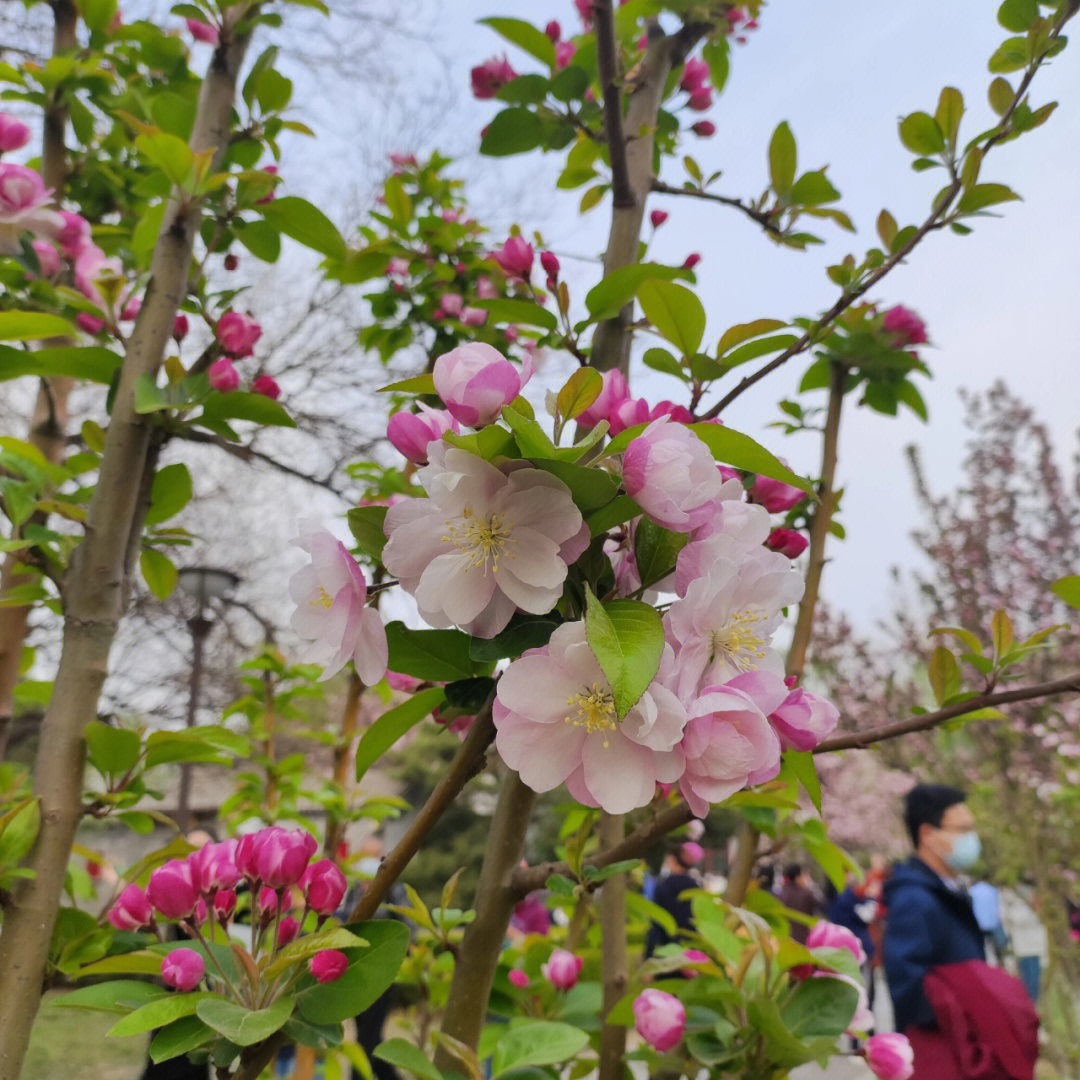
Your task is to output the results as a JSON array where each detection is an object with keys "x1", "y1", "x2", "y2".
[{"x1": 622, "y1": 417, "x2": 724, "y2": 532}]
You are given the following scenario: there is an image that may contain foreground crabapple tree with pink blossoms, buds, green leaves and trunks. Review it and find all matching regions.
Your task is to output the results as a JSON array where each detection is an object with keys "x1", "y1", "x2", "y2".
[{"x1": 0, "y1": 0, "x2": 1078, "y2": 1080}]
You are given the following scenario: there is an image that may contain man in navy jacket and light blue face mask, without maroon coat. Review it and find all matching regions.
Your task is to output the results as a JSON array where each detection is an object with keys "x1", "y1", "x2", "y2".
[{"x1": 885, "y1": 784, "x2": 986, "y2": 1032}]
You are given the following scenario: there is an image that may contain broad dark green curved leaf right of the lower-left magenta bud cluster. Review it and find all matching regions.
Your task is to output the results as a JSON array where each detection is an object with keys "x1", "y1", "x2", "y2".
[{"x1": 297, "y1": 919, "x2": 409, "y2": 1024}]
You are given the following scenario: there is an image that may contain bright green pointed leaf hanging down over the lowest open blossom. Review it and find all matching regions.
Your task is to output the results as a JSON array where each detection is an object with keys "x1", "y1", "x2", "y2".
[{"x1": 585, "y1": 590, "x2": 664, "y2": 720}]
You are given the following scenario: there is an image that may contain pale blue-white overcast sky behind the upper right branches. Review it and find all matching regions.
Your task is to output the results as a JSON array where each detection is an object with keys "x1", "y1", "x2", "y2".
[{"x1": 282, "y1": 0, "x2": 1080, "y2": 630}]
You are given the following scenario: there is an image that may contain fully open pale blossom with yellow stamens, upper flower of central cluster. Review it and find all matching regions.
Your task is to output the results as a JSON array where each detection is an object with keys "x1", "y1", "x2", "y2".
[{"x1": 382, "y1": 443, "x2": 589, "y2": 637}]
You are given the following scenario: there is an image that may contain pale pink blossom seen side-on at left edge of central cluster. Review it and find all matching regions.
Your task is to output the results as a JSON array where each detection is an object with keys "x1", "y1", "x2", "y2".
[{"x1": 288, "y1": 523, "x2": 387, "y2": 686}]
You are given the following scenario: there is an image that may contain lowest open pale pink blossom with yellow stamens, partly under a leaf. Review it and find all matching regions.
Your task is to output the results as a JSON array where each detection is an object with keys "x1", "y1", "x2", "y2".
[{"x1": 492, "y1": 622, "x2": 686, "y2": 813}]
